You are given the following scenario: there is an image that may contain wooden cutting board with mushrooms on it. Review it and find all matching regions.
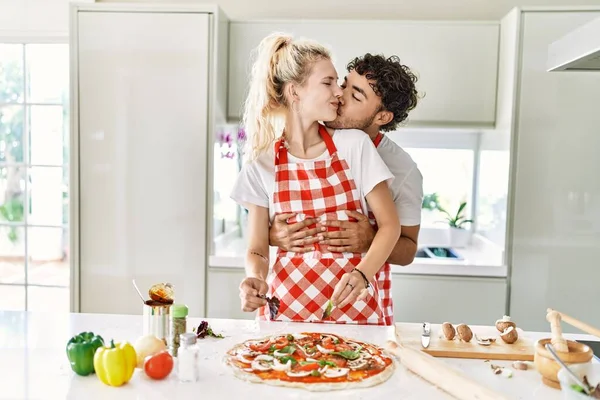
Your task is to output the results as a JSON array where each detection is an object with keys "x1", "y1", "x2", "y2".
[{"x1": 396, "y1": 323, "x2": 535, "y2": 361}]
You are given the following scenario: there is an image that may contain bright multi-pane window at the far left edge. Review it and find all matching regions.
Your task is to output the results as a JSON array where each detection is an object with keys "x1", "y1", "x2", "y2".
[{"x1": 0, "y1": 43, "x2": 70, "y2": 311}]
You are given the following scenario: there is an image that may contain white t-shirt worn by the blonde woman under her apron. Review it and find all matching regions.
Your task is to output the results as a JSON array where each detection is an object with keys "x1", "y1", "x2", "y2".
[{"x1": 231, "y1": 129, "x2": 394, "y2": 221}]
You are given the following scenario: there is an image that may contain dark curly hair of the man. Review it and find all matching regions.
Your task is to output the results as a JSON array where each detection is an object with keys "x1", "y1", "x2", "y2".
[{"x1": 346, "y1": 53, "x2": 418, "y2": 132}]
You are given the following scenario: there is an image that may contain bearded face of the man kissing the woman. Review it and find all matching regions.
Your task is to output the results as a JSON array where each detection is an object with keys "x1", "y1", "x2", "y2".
[{"x1": 325, "y1": 70, "x2": 381, "y2": 130}]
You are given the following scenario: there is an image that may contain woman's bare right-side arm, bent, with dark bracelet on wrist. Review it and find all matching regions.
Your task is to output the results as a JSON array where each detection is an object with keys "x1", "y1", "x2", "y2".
[{"x1": 331, "y1": 181, "x2": 401, "y2": 307}]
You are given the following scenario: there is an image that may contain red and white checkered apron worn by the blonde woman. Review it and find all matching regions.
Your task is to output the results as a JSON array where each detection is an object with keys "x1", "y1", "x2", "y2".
[{"x1": 258, "y1": 126, "x2": 384, "y2": 325}]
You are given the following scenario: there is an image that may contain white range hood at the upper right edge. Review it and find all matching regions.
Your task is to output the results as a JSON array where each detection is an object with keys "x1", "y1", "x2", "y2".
[{"x1": 547, "y1": 18, "x2": 600, "y2": 71}]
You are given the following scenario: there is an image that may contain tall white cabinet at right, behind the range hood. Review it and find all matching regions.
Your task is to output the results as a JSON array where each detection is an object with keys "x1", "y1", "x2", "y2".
[{"x1": 502, "y1": 6, "x2": 600, "y2": 332}]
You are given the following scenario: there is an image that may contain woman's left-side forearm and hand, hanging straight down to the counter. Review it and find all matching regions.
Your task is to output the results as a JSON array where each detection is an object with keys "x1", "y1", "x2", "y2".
[{"x1": 240, "y1": 204, "x2": 269, "y2": 312}]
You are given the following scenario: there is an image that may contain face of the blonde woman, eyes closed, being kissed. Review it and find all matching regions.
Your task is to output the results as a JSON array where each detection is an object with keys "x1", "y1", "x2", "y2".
[{"x1": 292, "y1": 59, "x2": 343, "y2": 121}]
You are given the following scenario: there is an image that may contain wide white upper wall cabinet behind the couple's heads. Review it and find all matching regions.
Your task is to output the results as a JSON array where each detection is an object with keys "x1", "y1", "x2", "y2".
[{"x1": 228, "y1": 21, "x2": 499, "y2": 126}]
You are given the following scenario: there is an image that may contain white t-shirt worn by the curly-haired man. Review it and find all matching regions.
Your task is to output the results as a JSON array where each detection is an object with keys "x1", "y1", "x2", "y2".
[{"x1": 377, "y1": 135, "x2": 423, "y2": 226}]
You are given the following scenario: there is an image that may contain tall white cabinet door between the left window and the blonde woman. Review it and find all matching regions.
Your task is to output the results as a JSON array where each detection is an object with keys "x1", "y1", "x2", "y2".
[{"x1": 74, "y1": 11, "x2": 209, "y2": 316}]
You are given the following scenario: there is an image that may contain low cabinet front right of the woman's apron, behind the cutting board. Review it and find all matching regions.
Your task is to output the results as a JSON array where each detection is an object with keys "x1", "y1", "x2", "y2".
[{"x1": 392, "y1": 275, "x2": 506, "y2": 325}]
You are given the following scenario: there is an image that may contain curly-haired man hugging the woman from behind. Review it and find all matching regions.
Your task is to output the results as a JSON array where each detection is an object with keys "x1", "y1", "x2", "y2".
[{"x1": 270, "y1": 53, "x2": 423, "y2": 324}]
